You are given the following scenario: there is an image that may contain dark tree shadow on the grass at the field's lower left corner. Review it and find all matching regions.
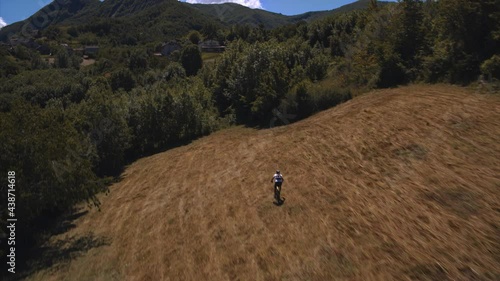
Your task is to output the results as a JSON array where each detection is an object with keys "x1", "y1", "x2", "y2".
[{"x1": 2, "y1": 211, "x2": 111, "y2": 280}]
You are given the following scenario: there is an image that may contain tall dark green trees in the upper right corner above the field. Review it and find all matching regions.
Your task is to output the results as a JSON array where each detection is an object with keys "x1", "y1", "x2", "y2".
[{"x1": 426, "y1": 0, "x2": 500, "y2": 83}]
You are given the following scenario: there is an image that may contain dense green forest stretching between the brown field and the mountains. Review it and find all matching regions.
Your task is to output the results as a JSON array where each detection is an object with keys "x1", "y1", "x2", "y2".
[{"x1": 0, "y1": 0, "x2": 500, "y2": 262}]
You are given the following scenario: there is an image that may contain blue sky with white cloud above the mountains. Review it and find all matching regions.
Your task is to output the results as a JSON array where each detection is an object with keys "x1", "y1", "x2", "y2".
[{"x1": 0, "y1": 0, "x2": 395, "y2": 28}]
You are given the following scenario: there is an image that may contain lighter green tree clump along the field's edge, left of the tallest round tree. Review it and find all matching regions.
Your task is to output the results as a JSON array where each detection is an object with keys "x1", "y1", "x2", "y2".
[{"x1": 128, "y1": 79, "x2": 218, "y2": 157}]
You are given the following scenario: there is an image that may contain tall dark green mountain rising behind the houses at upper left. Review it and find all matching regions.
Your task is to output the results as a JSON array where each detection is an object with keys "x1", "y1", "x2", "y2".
[{"x1": 0, "y1": 0, "x2": 217, "y2": 41}]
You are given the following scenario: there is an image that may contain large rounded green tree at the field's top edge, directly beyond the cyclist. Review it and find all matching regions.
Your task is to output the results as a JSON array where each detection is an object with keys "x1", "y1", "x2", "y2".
[{"x1": 209, "y1": 41, "x2": 289, "y2": 122}]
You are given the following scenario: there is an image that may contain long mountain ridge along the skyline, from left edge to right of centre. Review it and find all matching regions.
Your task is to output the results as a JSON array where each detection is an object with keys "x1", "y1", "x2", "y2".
[{"x1": 0, "y1": 0, "x2": 389, "y2": 42}]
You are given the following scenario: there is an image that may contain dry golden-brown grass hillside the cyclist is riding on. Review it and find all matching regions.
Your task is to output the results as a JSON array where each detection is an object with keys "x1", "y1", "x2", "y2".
[{"x1": 23, "y1": 86, "x2": 500, "y2": 280}]
